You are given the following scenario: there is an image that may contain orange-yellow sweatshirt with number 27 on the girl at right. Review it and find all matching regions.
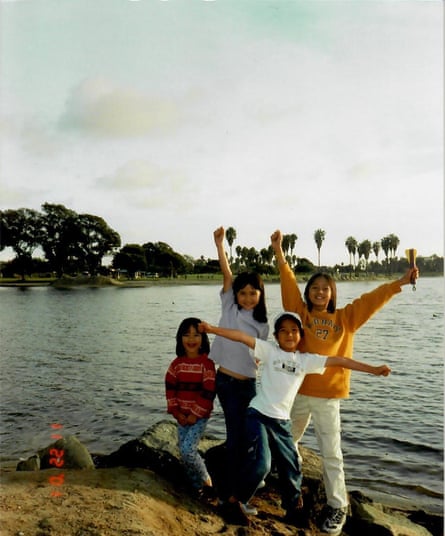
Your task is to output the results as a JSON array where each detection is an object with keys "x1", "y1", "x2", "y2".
[{"x1": 280, "y1": 264, "x2": 401, "y2": 398}]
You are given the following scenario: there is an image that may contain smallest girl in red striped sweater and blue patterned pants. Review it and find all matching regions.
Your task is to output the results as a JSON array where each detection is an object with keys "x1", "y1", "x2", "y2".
[{"x1": 165, "y1": 318, "x2": 216, "y2": 496}]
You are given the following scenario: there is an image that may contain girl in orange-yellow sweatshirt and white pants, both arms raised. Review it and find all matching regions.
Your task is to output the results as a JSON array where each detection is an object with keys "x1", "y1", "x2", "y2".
[{"x1": 271, "y1": 231, "x2": 419, "y2": 535}]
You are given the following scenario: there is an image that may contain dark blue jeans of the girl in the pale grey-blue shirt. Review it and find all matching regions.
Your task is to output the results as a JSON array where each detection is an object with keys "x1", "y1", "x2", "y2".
[{"x1": 216, "y1": 371, "x2": 256, "y2": 500}]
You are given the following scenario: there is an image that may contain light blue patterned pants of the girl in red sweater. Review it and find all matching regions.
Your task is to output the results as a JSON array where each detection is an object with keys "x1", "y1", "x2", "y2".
[{"x1": 178, "y1": 419, "x2": 210, "y2": 489}]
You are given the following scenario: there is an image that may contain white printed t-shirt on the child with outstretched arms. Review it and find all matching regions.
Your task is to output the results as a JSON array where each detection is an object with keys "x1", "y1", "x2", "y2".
[{"x1": 249, "y1": 339, "x2": 327, "y2": 420}]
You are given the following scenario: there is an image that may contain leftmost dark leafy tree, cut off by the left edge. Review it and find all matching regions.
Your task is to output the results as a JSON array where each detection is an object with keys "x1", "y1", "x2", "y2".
[{"x1": 0, "y1": 208, "x2": 42, "y2": 279}]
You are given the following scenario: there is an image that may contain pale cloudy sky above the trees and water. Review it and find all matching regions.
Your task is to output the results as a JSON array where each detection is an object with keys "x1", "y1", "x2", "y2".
[{"x1": 0, "y1": 0, "x2": 444, "y2": 265}]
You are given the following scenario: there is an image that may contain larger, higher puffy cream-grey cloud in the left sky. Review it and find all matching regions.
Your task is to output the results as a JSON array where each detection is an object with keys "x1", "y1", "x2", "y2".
[{"x1": 60, "y1": 78, "x2": 181, "y2": 138}]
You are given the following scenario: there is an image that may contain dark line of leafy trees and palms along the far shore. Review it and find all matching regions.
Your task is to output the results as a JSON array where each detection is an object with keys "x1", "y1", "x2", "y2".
[{"x1": 0, "y1": 203, "x2": 443, "y2": 278}]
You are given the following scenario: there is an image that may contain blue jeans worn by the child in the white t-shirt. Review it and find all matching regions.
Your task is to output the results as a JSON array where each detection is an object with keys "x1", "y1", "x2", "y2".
[{"x1": 237, "y1": 408, "x2": 303, "y2": 510}]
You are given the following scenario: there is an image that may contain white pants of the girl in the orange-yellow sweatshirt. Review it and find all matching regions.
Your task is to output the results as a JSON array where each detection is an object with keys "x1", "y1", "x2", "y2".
[{"x1": 291, "y1": 395, "x2": 348, "y2": 508}]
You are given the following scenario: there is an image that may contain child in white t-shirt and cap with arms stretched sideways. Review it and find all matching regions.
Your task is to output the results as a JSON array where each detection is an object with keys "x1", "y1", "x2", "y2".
[{"x1": 199, "y1": 311, "x2": 391, "y2": 523}]
